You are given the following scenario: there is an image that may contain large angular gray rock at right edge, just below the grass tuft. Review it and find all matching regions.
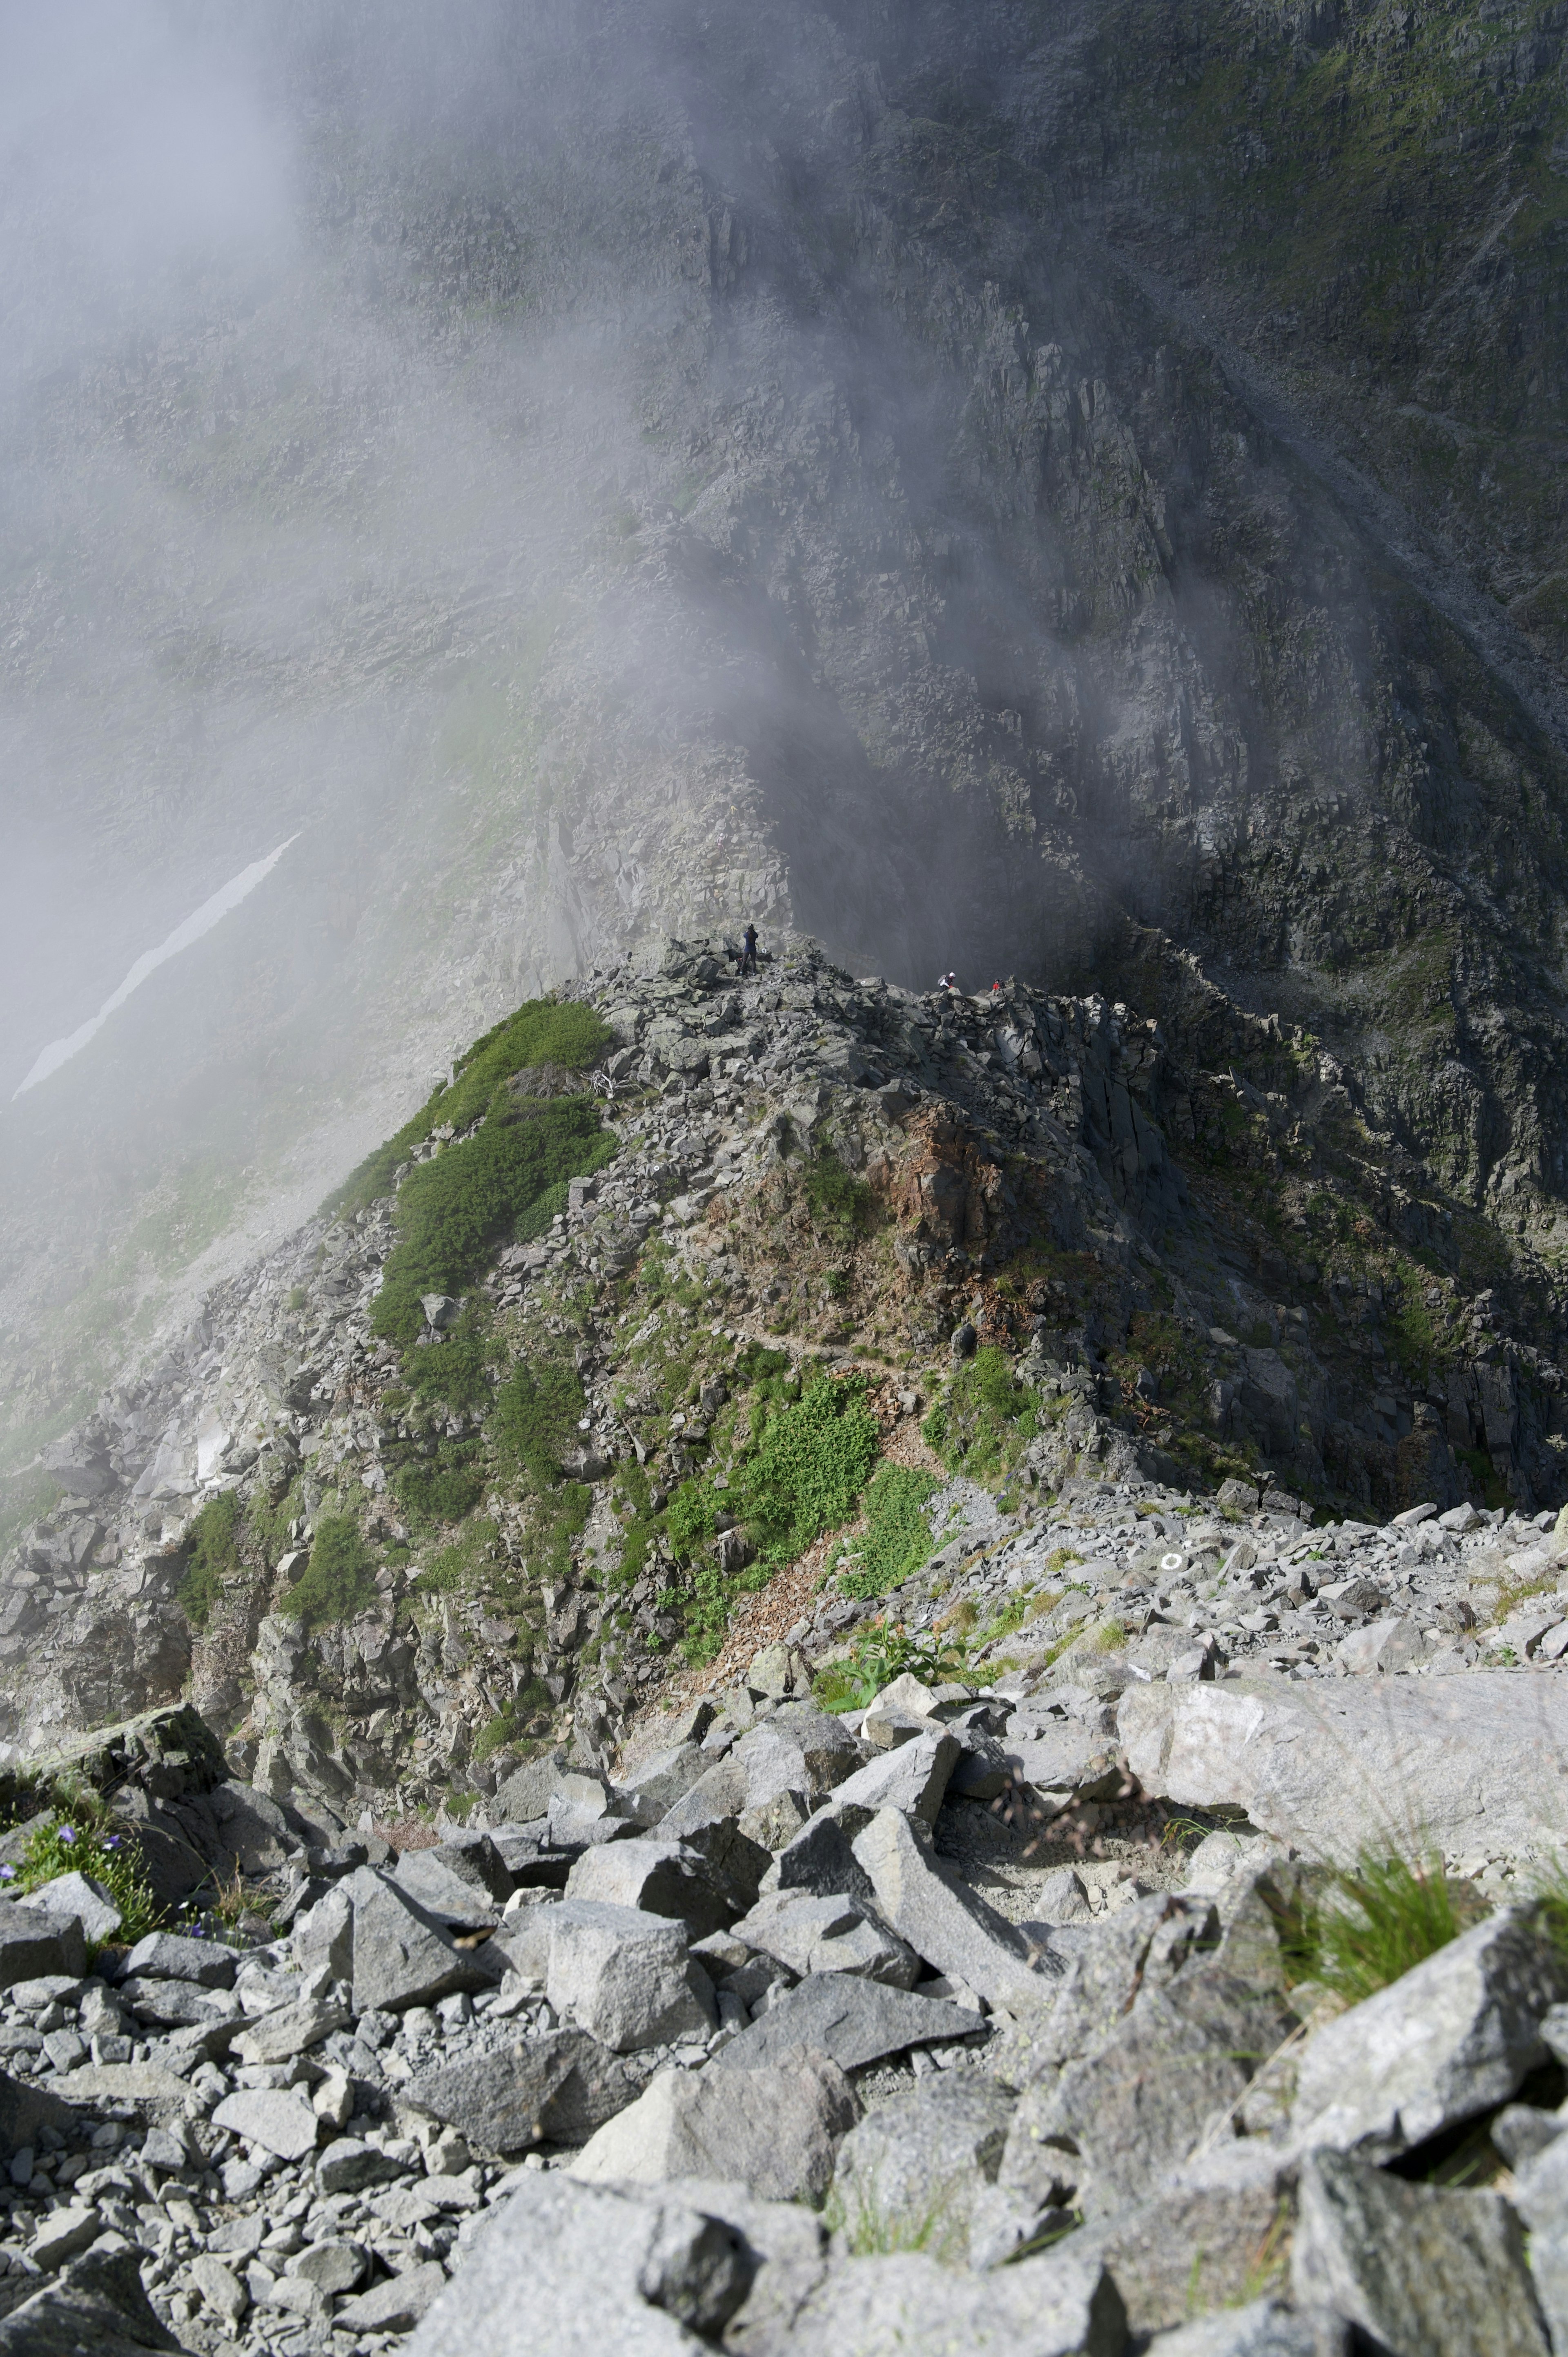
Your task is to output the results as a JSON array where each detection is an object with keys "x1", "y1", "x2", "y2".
[{"x1": 1290, "y1": 1911, "x2": 1568, "y2": 2161}]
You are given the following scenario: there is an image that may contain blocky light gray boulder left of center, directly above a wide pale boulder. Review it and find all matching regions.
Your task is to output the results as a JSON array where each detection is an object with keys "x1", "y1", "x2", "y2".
[{"x1": 545, "y1": 1900, "x2": 719, "y2": 2053}]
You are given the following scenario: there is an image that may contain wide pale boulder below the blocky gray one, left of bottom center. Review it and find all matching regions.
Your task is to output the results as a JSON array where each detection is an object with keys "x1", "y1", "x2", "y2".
[{"x1": 570, "y1": 2055, "x2": 856, "y2": 2204}]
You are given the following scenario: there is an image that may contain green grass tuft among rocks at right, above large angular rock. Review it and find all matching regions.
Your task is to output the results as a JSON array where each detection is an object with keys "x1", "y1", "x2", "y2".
[{"x1": 1276, "y1": 1848, "x2": 1490, "y2": 2006}]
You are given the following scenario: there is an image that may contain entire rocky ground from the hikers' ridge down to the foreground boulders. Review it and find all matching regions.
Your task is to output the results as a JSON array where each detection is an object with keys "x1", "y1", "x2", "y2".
[{"x1": 0, "y1": 938, "x2": 1568, "y2": 2357}]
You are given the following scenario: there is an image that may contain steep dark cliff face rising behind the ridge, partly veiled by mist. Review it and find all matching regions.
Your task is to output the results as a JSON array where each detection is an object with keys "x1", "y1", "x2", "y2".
[{"x1": 0, "y1": 0, "x2": 1568, "y2": 1452}]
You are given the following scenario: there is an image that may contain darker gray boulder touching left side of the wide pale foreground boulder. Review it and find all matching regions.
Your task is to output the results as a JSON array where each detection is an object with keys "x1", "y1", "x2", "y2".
[{"x1": 403, "y1": 2029, "x2": 637, "y2": 2152}]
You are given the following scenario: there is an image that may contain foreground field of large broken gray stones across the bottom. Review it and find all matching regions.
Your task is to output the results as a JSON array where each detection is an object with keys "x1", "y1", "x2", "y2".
[{"x1": 0, "y1": 1664, "x2": 1568, "y2": 2357}]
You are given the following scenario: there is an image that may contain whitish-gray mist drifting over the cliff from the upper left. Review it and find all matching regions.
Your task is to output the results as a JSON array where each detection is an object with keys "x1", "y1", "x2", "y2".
[{"x1": 0, "y1": 0, "x2": 1509, "y2": 1456}]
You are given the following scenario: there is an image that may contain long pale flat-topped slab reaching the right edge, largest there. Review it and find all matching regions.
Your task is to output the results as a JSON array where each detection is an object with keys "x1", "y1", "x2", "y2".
[{"x1": 1115, "y1": 1669, "x2": 1568, "y2": 1860}]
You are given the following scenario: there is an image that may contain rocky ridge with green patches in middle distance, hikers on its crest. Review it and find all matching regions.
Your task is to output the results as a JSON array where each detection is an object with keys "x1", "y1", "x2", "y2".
[{"x1": 0, "y1": 941, "x2": 1568, "y2": 1822}]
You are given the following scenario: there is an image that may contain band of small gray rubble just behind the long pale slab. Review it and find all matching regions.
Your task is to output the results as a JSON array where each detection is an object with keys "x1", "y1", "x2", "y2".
[{"x1": 790, "y1": 1476, "x2": 1568, "y2": 1725}]
